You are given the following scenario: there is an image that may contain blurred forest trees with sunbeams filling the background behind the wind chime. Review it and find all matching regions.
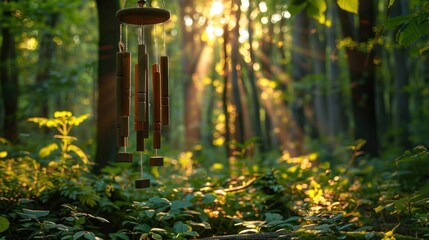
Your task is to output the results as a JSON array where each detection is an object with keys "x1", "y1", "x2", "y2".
[{"x1": 0, "y1": 0, "x2": 429, "y2": 171}]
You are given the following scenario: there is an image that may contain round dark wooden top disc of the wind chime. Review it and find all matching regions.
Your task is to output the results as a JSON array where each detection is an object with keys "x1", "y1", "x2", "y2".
[{"x1": 116, "y1": 7, "x2": 170, "y2": 25}]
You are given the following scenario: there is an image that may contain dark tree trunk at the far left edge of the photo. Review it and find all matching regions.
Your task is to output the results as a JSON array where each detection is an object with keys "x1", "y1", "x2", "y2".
[{"x1": 0, "y1": 4, "x2": 19, "y2": 143}]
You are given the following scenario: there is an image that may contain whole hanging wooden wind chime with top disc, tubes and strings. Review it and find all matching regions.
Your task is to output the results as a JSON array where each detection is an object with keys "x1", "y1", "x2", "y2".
[{"x1": 116, "y1": 1, "x2": 170, "y2": 188}]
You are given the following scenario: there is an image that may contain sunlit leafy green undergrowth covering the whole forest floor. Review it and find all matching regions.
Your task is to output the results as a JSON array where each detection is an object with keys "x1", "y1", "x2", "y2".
[{"x1": 0, "y1": 112, "x2": 429, "y2": 240}]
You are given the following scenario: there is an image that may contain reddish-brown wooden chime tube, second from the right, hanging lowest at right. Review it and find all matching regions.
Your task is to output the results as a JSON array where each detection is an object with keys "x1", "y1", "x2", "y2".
[{"x1": 152, "y1": 64, "x2": 161, "y2": 149}]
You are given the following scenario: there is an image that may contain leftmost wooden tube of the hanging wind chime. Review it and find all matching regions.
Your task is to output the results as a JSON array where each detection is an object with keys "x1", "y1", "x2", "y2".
[{"x1": 116, "y1": 52, "x2": 126, "y2": 147}]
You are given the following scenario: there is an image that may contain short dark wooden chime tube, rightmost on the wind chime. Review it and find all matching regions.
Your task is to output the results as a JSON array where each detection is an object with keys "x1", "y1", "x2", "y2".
[{"x1": 160, "y1": 56, "x2": 170, "y2": 125}]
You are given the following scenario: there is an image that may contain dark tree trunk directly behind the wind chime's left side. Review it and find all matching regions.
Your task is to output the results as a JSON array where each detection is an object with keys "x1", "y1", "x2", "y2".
[{"x1": 94, "y1": 0, "x2": 119, "y2": 172}]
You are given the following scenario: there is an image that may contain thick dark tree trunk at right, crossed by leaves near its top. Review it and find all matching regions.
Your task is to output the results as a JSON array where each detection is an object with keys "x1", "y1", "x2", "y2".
[{"x1": 340, "y1": 0, "x2": 379, "y2": 156}]
